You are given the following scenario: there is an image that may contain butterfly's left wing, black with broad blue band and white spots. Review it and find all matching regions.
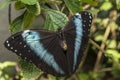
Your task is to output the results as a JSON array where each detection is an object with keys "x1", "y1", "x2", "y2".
[{"x1": 4, "y1": 30, "x2": 68, "y2": 76}]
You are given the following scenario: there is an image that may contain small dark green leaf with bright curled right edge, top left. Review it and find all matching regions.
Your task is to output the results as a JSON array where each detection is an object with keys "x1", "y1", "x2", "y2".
[{"x1": 26, "y1": 2, "x2": 41, "y2": 15}]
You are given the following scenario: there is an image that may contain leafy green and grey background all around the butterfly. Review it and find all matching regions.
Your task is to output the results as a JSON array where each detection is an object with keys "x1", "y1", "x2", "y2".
[{"x1": 0, "y1": 0, "x2": 120, "y2": 80}]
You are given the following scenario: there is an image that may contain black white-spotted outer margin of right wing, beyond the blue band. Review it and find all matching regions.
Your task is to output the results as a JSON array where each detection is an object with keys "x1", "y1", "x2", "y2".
[{"x1": 76, "y1": 12, "x2": 92, "y2": 69}]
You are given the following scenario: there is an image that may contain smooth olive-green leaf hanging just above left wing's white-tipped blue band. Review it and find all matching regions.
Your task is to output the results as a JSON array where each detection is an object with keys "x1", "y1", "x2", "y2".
[{"x1": 22, "y1": 12, "x2": 35, "y2": 29}]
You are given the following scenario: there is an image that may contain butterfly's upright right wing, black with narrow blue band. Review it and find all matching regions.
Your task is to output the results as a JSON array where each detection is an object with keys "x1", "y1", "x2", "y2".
[{"x1": 64, "y1": 12, "x2": 92, "y2": 73}]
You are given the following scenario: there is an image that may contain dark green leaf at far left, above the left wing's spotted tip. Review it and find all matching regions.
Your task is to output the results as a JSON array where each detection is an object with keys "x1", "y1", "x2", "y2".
[{"x1": 10, "y1": 13, "x2": 25, "y2": 33}]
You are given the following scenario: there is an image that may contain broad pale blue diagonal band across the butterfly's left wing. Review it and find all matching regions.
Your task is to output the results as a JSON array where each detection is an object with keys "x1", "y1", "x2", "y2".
[{"x1": 22, "y1": 30, "x2": 64, "y2": 74}]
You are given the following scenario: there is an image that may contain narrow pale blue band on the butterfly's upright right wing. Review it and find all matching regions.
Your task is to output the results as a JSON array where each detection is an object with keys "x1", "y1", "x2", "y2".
[{"x1": 73, "y1": 13, "x2": 83, "y2": 70}]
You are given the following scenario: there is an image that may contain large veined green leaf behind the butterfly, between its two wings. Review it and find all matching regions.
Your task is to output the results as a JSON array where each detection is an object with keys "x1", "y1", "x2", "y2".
[{"x1": 44, "y1": 9, "x2": 68, "y2": 31}]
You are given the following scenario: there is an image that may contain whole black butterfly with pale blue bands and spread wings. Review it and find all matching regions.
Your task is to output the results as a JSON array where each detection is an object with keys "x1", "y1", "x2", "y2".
[{"x1": 4, "y1": 11, "x2": 92, "y2": 77}]
